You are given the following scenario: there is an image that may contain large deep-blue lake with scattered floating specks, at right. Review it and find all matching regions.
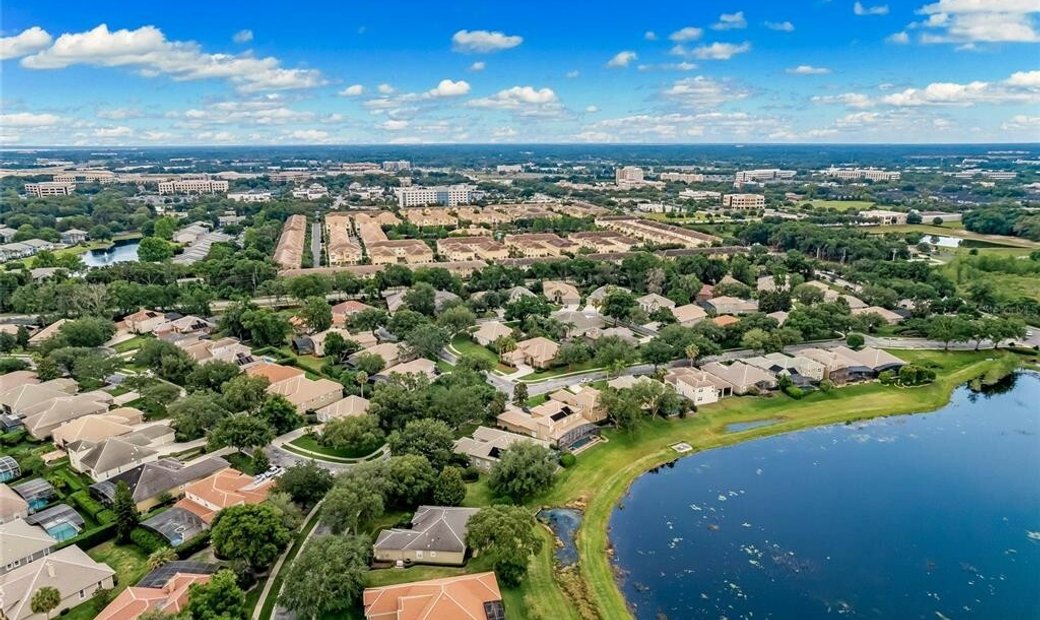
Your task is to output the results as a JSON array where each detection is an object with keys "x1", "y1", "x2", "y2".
[{"x1": 609, "y1": 373, "x2": 1040, "y2": 620}]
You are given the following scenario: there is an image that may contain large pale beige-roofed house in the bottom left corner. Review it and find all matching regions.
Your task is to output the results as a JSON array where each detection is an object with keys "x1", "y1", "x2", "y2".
[{"x1": 0, "y1": 545, "x2": 115, "y2": 620}]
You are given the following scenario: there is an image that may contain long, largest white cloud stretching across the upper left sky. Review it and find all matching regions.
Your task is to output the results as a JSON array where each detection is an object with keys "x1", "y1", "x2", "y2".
[{"x1": 22, "y1": 24, "x2": 324, "y2": 92}]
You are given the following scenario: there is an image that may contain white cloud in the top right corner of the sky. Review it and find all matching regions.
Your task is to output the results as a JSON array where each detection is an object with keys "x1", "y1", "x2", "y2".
[{"x1": 909, "y1": 0, "x2": 1040, "y2": 43}]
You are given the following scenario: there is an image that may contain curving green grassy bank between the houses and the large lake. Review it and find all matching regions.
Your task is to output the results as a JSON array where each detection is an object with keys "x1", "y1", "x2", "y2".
[{"x1": 520, "y1": 351, "x2": 1031, "y2": 619}]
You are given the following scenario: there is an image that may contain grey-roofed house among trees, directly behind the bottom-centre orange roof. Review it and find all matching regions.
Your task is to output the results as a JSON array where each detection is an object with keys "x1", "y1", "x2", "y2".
[{"x1": 372, "y1": 506, "x2": 479, "y2": 566}]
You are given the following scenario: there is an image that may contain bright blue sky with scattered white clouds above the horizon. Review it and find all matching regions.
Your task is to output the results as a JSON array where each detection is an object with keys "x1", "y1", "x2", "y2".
[{"x1": 0, "y1": 0, "x2": 1040, "y2": 147}]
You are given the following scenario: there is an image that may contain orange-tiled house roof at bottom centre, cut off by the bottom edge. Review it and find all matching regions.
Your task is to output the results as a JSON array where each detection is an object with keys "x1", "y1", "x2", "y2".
[{"x1": 363, "y1": 572, "x2": 505, "y2": 620}]
